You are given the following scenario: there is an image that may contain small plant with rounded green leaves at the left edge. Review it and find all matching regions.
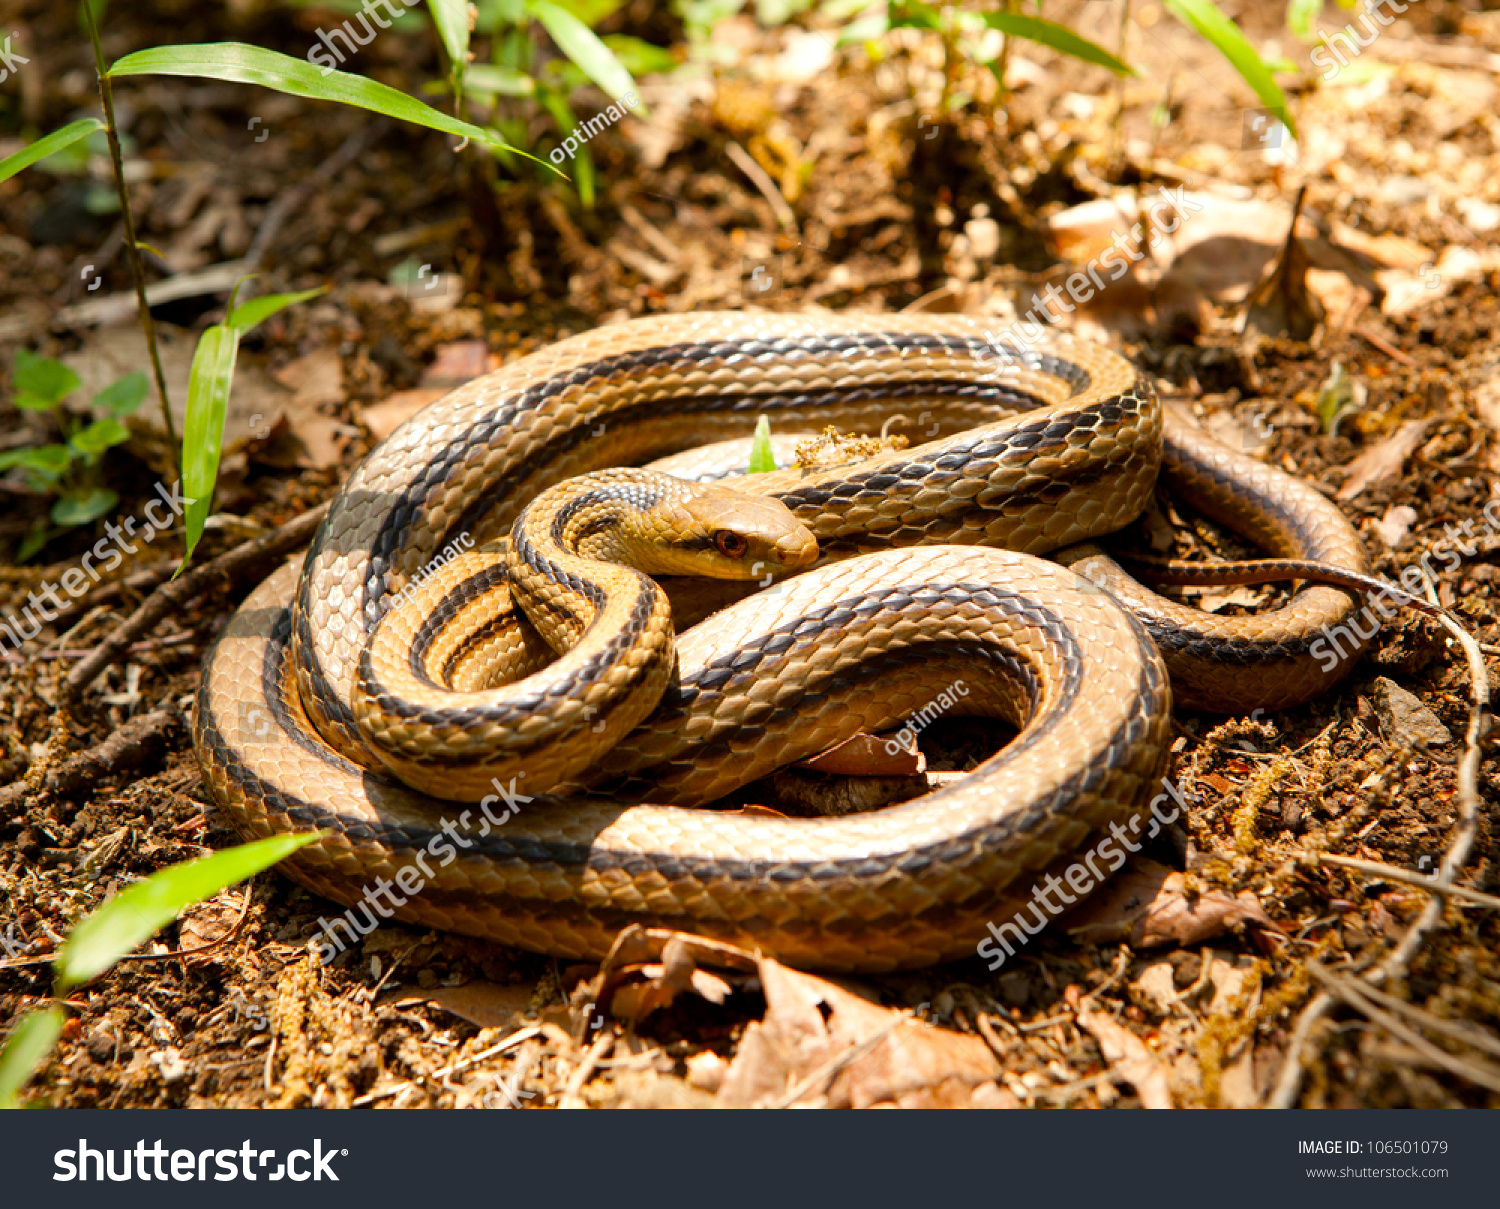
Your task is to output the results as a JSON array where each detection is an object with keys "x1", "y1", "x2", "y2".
[{"x1": 0, "y1": 348, "x2": 147, "y2": 563}]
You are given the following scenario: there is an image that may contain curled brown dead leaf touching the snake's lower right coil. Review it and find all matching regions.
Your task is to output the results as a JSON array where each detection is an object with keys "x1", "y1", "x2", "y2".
[{"x1": 1067, "y1": 860, "x2": 1278, "y2": 948}]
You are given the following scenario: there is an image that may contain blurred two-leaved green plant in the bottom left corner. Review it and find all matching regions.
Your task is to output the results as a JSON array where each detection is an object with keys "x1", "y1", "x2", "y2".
[{"x1": 0, "y1": 831, "x2": 320, "y2": 1109}]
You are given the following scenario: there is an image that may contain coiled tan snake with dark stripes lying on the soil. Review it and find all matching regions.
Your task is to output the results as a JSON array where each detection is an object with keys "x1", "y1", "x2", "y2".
[{"x1": 194, "y1": 312, "x2": 1367, "y2": 972}]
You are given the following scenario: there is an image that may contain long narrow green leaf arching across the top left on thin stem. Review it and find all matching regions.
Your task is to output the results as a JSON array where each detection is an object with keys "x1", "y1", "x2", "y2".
[{"x1": 108, "y1": 42, "x2": 513, "y2": 144}]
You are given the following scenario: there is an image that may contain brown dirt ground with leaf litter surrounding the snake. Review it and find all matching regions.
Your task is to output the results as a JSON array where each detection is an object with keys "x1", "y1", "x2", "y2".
[{"x1": 0, "y1": 0, "x2": 1500, "y2": 1107}]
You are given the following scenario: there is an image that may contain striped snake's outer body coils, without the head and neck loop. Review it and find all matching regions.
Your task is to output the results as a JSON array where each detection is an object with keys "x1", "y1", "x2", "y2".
[{"x1": 195, "y1": 314, "x2": 1364, "y2": 971}]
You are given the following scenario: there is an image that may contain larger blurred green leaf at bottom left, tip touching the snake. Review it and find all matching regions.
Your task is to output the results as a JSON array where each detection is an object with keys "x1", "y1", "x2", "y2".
[{"x1": 54, "y1": 834, "x2": 320, "y2": 989}]
